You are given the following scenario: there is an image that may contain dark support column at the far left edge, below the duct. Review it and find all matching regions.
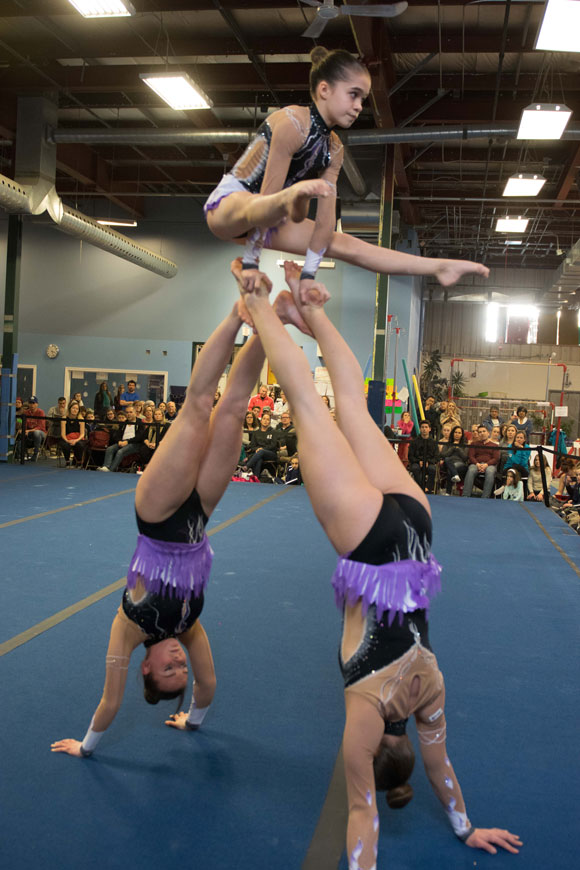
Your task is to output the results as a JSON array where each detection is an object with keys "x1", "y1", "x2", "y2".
[{"x1": 0, "y1": 215, "x2": 22, "y2": 462}]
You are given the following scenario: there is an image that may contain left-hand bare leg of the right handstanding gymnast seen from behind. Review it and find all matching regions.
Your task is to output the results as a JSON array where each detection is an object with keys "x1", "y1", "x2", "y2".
[{"x1": 233, "y1": 264, "x2": 382, "y2": 554}]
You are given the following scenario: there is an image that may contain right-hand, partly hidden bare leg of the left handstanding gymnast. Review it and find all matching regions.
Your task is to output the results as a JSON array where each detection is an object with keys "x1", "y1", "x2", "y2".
[{"x1": 196, "y1": 335, "x2": 264, "y2": 516}]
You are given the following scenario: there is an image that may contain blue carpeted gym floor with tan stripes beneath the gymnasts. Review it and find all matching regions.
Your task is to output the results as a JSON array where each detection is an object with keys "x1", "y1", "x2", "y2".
[{"x1": 0, "y1": 463, "x2": 580, "y2": 870}]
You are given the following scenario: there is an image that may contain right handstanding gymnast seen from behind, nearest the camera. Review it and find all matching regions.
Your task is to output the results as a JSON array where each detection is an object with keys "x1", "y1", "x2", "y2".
[{"x1": 232, "y1": 260, "x2": 521, "y2": 870}]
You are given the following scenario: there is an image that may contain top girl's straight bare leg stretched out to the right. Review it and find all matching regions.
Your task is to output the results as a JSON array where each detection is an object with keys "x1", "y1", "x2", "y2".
[{"x1": 268, "y1": 220, "x2": 489, "y2": 287}]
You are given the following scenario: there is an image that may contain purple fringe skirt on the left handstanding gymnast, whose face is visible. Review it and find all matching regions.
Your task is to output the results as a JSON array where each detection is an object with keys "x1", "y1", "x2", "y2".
[{"x1": 127, "y1": 534, "x2": 213, "y2": 599}]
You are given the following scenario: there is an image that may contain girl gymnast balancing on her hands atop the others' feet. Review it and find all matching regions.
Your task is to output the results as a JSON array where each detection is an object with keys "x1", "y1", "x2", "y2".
[{"x1": 204, "y1": 46, "x2": 489, "y2": 302}]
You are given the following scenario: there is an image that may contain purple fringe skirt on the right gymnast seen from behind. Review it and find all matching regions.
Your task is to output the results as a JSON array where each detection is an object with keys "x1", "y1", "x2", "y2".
[{"x1": 332, "y1": 556, "x2": 441, "y2": 625}]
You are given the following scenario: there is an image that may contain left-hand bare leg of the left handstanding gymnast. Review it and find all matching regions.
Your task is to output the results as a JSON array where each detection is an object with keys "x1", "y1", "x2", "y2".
[{"x1": 135, "y1": 303, "x2": 242, "y2": 523}]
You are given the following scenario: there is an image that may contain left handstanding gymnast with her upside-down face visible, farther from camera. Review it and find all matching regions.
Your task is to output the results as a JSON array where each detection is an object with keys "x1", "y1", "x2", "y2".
[{"x1": 51, "y1": 301, "x2": 264, "y2": 756}]
